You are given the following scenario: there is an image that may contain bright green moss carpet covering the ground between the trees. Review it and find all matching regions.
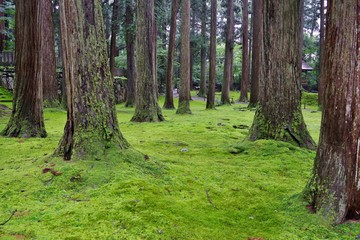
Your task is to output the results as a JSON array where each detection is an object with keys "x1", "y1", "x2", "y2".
[{"x1": 0, "y1": 89, "x2": 360, "y2": 239}]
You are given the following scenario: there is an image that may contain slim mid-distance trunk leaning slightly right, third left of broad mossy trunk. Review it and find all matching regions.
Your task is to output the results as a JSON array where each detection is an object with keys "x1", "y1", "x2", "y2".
[{"x1": 221, "y1": 0, "x2": 234, "y2": 104}]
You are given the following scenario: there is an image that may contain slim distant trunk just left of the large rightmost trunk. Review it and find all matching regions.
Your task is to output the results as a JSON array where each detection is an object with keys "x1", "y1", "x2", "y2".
[{"x1": 318, "y1": 0, "x2": 325, "y2": 107}]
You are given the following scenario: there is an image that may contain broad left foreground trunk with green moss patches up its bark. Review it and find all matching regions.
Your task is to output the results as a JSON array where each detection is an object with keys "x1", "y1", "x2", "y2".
[{"x1": 57, "y1": 0, "x2": 129, "y2": 160}]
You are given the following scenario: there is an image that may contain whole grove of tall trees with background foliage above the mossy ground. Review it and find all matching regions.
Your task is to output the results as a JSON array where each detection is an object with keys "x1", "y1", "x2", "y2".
[{"x1": 0, "y1": 0, "x2": 360, "y2": 223}]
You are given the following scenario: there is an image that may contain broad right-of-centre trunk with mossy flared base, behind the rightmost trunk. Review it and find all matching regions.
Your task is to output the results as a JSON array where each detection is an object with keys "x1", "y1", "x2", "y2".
[{"x1": 250, "y1": 0, "x2": 315, "y2": 149}]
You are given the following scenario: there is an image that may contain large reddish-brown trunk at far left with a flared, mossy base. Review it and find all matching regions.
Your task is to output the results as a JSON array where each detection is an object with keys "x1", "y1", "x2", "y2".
[{"x1": 2, "y1": 0, "x2": 46, "y2": 137}]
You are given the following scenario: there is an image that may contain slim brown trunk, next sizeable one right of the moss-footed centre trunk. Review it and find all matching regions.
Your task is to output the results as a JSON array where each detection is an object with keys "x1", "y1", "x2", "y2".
[{"x1": 206, "y1": 0, "x2": 217, "y2": 109}]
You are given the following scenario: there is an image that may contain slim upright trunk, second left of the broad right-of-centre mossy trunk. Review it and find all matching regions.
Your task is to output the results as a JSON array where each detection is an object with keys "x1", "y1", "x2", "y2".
[{"x1": 239, "y1": 0, "x2": 249, "y2": 102}]
